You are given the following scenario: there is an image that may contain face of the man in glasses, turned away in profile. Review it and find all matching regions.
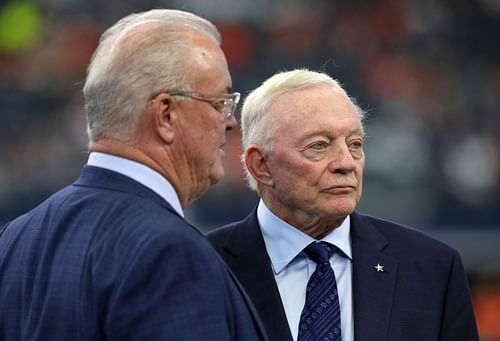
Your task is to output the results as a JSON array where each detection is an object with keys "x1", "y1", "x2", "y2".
[{"x1": 176, "y1": 33, "x2": 236, "y2": 201}]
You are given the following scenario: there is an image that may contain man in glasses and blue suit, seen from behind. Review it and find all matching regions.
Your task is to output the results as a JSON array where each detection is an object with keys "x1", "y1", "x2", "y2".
[{"x1": 0, "y1": 10, "x2": 266, "y2": 341}]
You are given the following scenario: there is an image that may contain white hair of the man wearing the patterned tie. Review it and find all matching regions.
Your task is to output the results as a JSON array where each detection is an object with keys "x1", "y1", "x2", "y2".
[{"x1": 241, "y1": 69, "x2": 365, "y2": 192}]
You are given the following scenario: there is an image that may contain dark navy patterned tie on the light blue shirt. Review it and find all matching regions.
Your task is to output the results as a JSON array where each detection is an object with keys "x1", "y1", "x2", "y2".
[{"x1": 298, "y1": 242, "x2": 342, "y2": 341}]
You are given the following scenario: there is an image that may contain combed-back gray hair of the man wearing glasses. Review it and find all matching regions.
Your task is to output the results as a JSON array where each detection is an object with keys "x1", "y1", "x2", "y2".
[{"x1": 83, "y1": 9, "x2": 221, "y2": 142}]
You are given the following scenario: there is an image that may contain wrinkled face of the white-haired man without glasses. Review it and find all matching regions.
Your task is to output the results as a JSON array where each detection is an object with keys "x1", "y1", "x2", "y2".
[{"x1": 264, "y1": 86, "x2": 365, "y2": 226}]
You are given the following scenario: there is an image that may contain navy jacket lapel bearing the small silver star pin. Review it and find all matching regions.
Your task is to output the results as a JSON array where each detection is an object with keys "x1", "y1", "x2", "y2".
[{"x1": 351, "y1": 213, "x2": 398, "y2": 341}]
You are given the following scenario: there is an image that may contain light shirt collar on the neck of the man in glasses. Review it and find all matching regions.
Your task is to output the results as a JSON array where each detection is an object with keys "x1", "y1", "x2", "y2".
[{"x1": 87, "y1": 152, "x2": 184, "y2": 217}]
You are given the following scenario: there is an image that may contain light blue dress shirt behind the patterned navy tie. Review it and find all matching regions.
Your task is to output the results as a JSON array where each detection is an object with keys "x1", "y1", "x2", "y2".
[{"x1": 257, "y1": 200, "x2": 354, "y2": 341}]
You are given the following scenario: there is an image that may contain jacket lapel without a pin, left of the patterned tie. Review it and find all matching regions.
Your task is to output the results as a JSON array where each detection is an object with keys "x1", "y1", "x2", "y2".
[{"x1": 219, "y1": 210, "x2": 292, "y2": 340}]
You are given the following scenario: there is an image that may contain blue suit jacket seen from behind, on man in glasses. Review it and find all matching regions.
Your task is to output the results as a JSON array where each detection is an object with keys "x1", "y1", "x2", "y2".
[{"x1": 0, "y1": 166, "x2": 264, "y2": 341}]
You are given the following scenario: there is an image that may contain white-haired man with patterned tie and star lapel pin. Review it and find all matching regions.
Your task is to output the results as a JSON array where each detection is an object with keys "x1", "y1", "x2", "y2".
[{"x1": 209, "y1": 69, "x2": 478, "y2": 341}]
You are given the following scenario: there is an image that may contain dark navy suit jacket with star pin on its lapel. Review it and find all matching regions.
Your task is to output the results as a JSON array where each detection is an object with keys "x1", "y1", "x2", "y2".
[{"x1": 208, "y1": 206, "x2": 479, "y2": 341}]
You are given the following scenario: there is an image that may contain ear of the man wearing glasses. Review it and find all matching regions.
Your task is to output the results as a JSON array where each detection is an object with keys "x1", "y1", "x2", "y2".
[{"x1": 152, "y1": 93, "x2": 178, "y2": 144}]
